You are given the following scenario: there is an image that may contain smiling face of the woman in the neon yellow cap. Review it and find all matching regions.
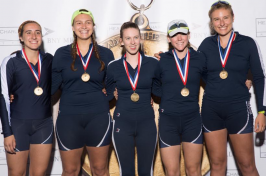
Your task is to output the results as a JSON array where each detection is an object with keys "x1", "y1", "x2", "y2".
[{"x1": 72, "y1": 14, "x2": 94, "y2": 40}]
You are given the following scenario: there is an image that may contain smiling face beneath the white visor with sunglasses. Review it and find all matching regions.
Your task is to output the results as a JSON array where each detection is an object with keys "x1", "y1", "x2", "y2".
[{"x1": 167, "y1": 33, "x2": 190, "y2": 52}]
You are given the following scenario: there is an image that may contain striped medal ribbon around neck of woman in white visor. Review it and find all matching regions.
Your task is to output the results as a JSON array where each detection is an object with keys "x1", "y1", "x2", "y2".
[{"x1": 173, "y1": 49, "x2": 190, "y2": 86}]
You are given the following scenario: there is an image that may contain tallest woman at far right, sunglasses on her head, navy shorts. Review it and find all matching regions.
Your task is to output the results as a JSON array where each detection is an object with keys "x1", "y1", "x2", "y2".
[{"x1": 199, "y1": 1, "x2": 266, "y2": 176}]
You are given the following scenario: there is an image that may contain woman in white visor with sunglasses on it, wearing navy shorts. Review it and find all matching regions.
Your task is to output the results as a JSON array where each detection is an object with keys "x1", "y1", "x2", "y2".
[{"x1": 153, "y1": 20, "x2": 205, "y2": 176}]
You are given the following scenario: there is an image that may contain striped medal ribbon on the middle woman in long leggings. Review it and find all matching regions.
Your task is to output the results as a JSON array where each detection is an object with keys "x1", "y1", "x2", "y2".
[{"x1": 123, "y1": 53, "x2": 142, "y2": 91}]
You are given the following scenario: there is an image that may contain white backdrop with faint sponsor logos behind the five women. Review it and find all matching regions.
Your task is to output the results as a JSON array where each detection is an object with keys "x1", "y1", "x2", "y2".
[{"x1": 0, "y1": 0, "x2": 266, "y2": 176}]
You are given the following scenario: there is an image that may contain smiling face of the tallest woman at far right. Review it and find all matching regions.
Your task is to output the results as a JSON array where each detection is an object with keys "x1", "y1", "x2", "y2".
[{"x1": 211, "y1": 8, "x2": 234, "y2": 36}]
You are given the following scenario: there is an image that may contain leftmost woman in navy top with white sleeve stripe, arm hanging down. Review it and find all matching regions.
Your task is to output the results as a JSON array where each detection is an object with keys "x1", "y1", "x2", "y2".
[{"x1": 0, "y1": 21, "x2": 53, "y2": 176}]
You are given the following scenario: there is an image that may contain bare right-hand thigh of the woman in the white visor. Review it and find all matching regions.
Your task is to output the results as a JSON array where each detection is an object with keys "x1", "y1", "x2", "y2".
[{"x1": 182, "y1": 142, "x2": 203, "y2": 170}]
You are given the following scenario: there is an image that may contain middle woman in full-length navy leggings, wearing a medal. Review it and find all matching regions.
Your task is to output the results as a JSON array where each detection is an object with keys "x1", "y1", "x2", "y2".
[{"x1": 106, "y1": 22, "x2": 158, "y2": 176}]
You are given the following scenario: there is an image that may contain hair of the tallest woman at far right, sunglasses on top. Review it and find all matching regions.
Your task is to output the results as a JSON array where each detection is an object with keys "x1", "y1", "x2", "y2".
[{"x1": 209, "y1": 2, "x2": 234, "y2": 35}]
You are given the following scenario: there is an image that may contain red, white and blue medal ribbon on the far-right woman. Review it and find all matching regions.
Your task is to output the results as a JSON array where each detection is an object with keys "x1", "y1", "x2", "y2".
[{"x1": 218, "y1": 31, "x2": 236, "y2": 68}]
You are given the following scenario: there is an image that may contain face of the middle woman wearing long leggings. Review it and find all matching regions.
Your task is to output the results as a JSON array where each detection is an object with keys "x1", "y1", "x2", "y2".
[{"x1": 120, "y1": 28, "x2": 141, "y2": 55}]
